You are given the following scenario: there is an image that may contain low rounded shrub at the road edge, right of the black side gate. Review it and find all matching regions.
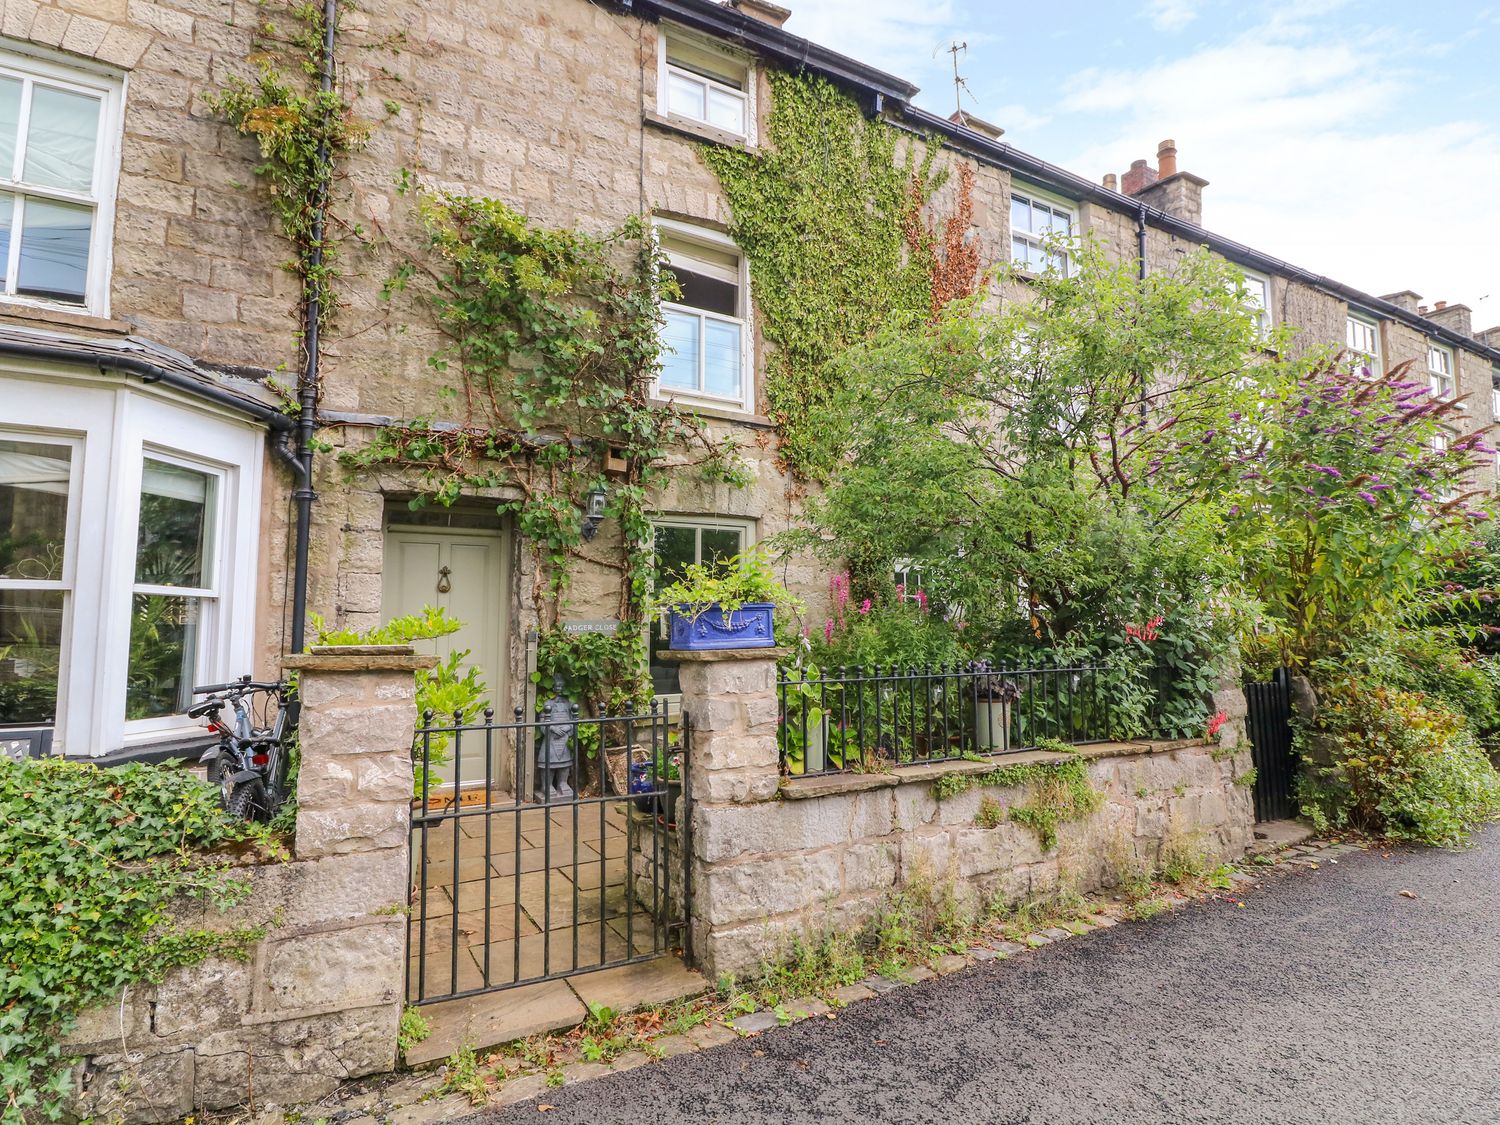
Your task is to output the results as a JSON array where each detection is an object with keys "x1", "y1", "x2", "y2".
[{"x1": 1298, "y1": 683, "x2": 1500, "y2": 845}]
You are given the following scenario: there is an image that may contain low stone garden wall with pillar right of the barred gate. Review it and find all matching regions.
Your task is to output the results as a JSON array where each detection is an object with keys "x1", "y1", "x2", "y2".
[{"x1": 677, "y1": 650, "x2": 1254, "y2": 975}]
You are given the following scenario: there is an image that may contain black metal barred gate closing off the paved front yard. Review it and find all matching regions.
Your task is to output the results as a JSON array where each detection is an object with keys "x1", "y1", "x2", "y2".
[{"x1": 407, "y1": 704, "x2": 692, "y2": 1004}]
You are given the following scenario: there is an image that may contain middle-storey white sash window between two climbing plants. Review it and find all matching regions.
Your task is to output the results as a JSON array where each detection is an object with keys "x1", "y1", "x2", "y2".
[{"x1": 657, "y1": 219, "x2": 752, "y2": 410}]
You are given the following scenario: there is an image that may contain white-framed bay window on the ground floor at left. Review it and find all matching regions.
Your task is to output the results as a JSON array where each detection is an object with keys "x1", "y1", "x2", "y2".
[{"x1": 0, "y1": 374, "x2": 264, "y2": 756}]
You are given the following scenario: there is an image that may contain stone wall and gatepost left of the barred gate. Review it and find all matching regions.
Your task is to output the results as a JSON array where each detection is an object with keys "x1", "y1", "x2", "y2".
[{"x1": 68, "y1": 650, "x2": 426, "y2": 1122}]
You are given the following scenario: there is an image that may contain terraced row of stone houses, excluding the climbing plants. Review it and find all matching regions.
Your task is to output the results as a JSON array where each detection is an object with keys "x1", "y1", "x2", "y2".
[{"x1": 0, "y1": 0, "x2": 1500, "y2": 761}]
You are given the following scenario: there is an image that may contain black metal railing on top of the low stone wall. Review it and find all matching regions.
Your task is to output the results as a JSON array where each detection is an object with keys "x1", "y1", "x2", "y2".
[{"x1": 777, "y1": 662, "x2": 1110, "y2": 774}]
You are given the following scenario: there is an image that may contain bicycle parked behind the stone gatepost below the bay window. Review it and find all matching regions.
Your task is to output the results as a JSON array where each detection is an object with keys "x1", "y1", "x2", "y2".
[{"x1": 188, "y1": 675, "x2": 296, "y2": 824}]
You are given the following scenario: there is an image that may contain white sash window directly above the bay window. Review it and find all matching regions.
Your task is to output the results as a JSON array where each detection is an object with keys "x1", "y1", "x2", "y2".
[{"x1": 0, "y1": 51, "x2": 120, "y2": 315}]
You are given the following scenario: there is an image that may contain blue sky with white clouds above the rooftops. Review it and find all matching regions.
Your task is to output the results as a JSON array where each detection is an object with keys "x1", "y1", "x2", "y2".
[{"x1": 783, "y1": 0, "x2": 1500, "y2": 329}]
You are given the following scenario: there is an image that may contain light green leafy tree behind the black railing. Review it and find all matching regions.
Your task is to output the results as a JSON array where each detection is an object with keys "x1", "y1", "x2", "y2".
[{"x1": 791, "y1": 243, "x2": 1256, "y2": 657}]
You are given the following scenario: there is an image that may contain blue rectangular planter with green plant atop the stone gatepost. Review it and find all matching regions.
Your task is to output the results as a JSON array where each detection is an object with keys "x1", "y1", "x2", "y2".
[{"x1": 653, "y1": 552, "x2": 794, "y2": 651}]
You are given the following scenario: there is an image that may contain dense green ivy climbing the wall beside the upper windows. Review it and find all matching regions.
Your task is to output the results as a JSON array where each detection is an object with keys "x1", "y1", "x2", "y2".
[{"x1": 701, "y1": 71, "x2": 942, "y2": 476}]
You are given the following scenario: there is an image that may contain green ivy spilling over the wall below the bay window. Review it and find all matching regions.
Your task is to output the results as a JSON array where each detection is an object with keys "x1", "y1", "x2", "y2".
[{"x1": 0, "y1": 759, "x2": 266, "y2": 1122}]
